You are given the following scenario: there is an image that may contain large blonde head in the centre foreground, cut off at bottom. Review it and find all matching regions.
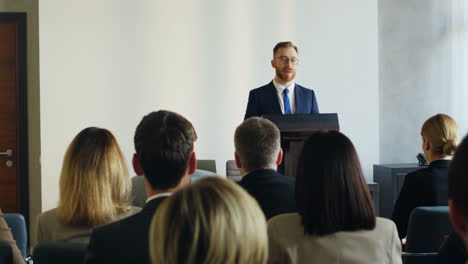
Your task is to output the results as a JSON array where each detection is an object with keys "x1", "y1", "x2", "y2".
[{"x1": 150, "y1": 177, "x2": 268, "y2": 264}]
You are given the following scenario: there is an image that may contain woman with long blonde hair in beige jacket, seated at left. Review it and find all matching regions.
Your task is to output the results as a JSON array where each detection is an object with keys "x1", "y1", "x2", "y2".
[{"x1": 37, "y1": 127, "x2": 140, "y2": 243}]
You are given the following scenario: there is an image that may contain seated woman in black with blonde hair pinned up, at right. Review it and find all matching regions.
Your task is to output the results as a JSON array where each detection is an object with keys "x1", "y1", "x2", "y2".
[{"x1": 392, "y1": 114, "x2": 458, "y2": 239}]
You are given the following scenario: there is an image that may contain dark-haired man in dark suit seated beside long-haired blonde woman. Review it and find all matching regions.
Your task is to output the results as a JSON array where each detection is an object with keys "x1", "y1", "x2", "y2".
[{"x1": 85, "y1": 111, "x2": 196, "y2": 264}]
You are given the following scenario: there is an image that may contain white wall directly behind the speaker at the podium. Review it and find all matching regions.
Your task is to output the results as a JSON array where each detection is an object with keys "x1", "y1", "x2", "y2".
[{"x1": 39, "y1": 0, "x2": 379, "y2": 209}]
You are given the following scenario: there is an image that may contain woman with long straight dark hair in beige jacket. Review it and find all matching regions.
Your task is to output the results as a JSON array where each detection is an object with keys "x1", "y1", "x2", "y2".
[{"x1": 268, "y1": 131, "x2": 402, "y2": 264}]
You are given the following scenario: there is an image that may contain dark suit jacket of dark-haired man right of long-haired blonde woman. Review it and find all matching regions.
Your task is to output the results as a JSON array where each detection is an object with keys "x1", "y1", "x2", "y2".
[{"x1": 85, "y1": 197, "x2": 166, "y2": 264}]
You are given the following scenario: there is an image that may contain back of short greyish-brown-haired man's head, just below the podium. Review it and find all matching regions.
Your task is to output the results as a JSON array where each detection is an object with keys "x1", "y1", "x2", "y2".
[{"x1": 234, "y1": 117, "x2": 280, "y2": 171}]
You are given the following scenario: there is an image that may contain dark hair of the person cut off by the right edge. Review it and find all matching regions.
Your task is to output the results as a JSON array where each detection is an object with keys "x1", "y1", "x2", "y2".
[{"x1": 448, "y1": 136, "x2": 468, "y2": 217}]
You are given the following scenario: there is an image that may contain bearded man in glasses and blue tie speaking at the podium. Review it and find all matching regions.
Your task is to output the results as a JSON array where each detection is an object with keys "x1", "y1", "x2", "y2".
[{"x1": 244, "y1": 41, "x2": 319, "y2": 119}]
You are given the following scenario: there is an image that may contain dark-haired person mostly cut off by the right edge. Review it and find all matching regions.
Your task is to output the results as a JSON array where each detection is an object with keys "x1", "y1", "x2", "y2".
[{"x1": 438, "y1": 137, "x2": 468, "y2": 264}]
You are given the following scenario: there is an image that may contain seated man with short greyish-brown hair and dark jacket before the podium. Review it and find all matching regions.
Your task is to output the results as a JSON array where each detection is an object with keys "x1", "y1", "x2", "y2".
[{"x1": 234, "y1": 117, "x2": 296, "y2": 219}]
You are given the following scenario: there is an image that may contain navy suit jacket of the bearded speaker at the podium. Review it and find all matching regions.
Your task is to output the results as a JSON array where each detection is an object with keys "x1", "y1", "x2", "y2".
[{"x1": 244, "y1": 81, "x2": 319, "y2": 119}]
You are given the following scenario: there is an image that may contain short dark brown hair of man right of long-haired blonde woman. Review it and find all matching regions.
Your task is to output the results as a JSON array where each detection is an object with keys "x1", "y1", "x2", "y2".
[{"x1": 134, "y1": 110, "x2": 195, "y2": 189}]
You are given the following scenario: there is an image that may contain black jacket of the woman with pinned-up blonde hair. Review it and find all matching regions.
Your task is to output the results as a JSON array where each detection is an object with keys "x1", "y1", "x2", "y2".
[{"x1": 392, "y1": 160, "x2": 450, "y2": 238}]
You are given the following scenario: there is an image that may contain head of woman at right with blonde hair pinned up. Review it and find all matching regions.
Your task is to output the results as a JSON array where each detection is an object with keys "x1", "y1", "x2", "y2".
[{"x1": 421, "y1": 114, "x2": 458, "y2": 156}]
